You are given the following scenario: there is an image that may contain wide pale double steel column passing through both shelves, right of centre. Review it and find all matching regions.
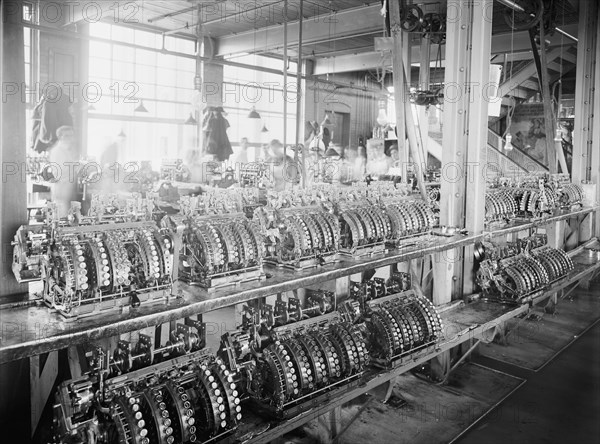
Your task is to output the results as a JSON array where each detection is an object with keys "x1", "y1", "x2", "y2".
[{"x1": 433, "y1": 0, "x2": 493, "y2": 304}]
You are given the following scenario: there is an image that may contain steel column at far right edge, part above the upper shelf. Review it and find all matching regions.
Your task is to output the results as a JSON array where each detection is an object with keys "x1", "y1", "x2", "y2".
[{"x1": 571, "y1": 1, "x2": 600, "y2": 183}]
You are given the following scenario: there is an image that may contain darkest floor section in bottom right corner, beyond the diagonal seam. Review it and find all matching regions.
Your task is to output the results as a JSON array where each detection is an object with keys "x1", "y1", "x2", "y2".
[{"x1": 457, "y1": 323, "x2": 600, "y2": 444}]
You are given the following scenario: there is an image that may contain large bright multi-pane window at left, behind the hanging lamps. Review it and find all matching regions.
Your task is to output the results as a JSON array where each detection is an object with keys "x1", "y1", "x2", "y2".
[{"x1": 88, "y1": 22, "x2": 196, "y2": 168}]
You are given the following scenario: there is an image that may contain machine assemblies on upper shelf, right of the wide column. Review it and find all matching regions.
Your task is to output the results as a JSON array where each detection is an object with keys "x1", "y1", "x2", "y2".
[{"x1": 485, "y1": 175, "x2": 584, "y2": 223}]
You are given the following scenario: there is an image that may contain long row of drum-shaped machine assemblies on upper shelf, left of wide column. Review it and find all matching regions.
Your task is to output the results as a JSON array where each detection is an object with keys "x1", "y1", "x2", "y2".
[{"x1": 13, "y1": 187, "x2": 435, "y2": 317}]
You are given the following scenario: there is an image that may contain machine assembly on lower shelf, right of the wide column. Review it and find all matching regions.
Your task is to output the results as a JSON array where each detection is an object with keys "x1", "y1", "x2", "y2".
[{"x1": 475, "y1": 234, "x2": 574, "y2": 302}]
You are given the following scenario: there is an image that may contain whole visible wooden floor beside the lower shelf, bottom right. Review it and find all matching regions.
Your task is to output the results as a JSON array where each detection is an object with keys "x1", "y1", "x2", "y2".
[{"x1": 281, "y1": 282, "x2": 600, "y2": 444}]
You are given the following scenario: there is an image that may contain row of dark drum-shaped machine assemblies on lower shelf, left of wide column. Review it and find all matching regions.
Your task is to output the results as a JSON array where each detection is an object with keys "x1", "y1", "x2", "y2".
[{"x1": 53, "y1": 273, "x2": 443, "y2": 444}]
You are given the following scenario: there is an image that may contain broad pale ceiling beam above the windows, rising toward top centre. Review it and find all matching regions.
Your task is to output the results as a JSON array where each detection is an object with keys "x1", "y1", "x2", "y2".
[{"x1": 217, "y1": 4, "x2": 382, "y2": 56}]
